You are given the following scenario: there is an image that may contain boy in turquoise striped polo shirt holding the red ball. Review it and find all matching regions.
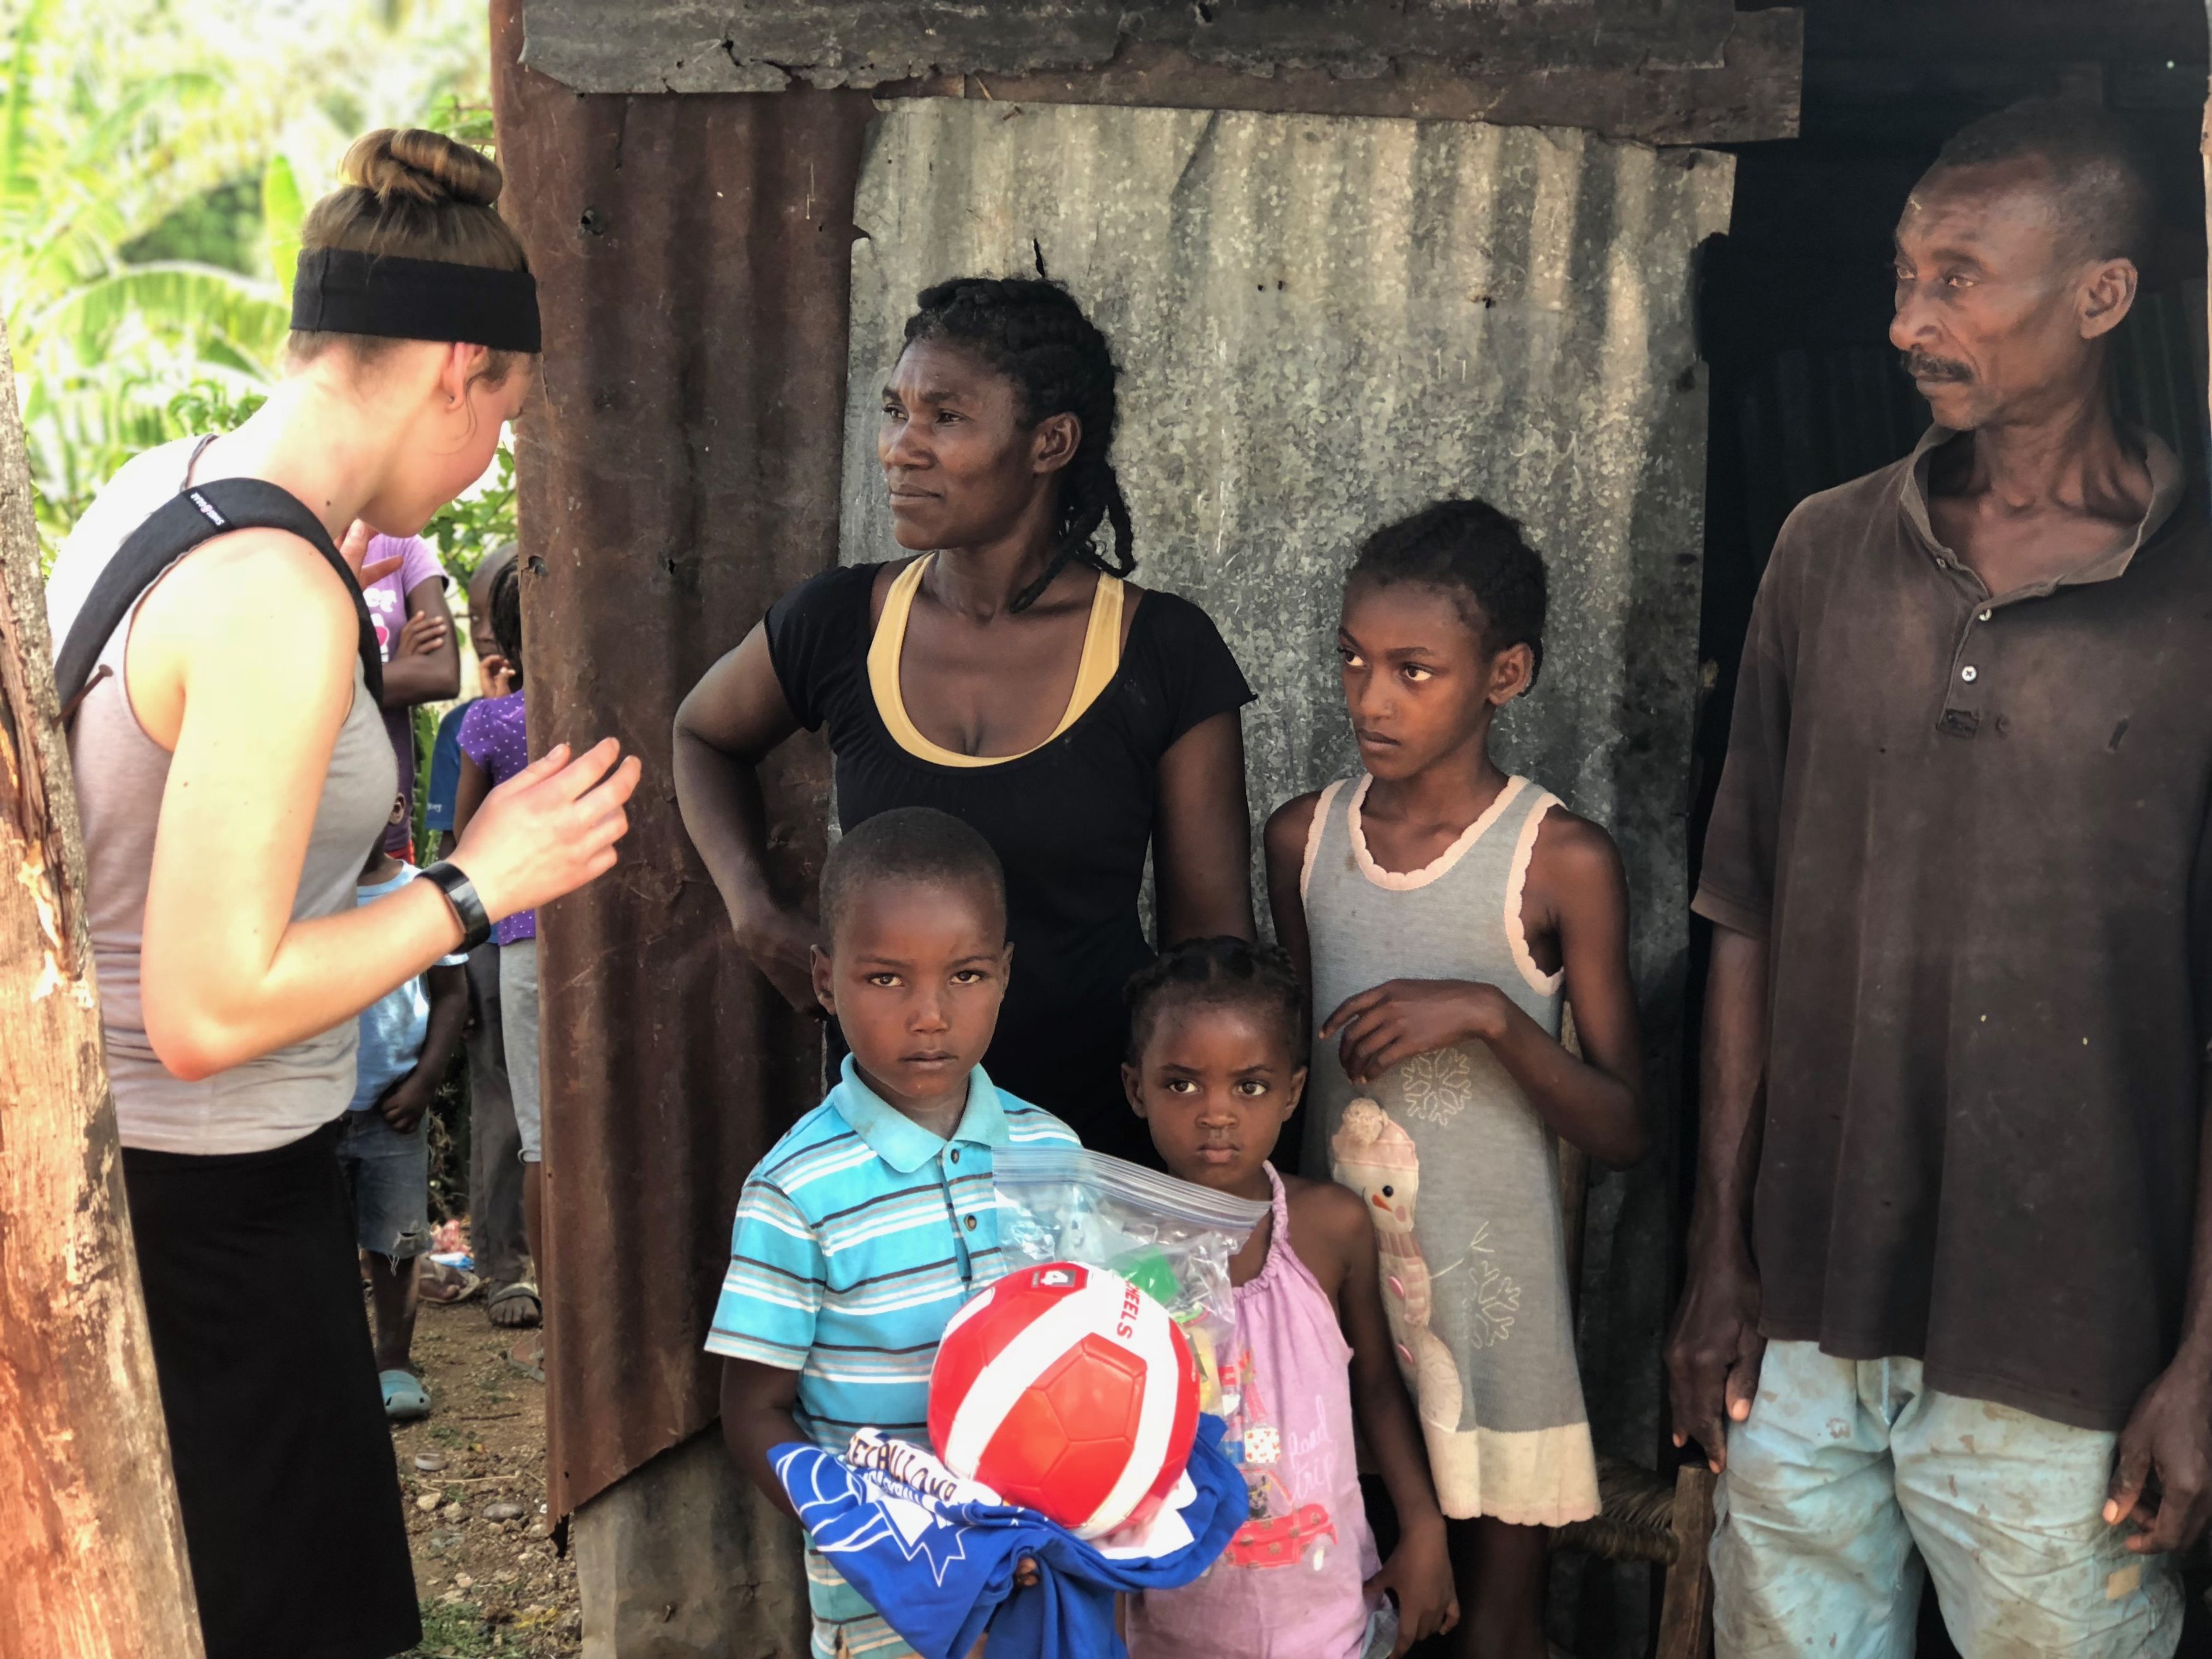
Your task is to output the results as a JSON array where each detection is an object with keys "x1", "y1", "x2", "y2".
[{"x1": 706, "y1": 808, "x2": 1075, "y2": 1659}]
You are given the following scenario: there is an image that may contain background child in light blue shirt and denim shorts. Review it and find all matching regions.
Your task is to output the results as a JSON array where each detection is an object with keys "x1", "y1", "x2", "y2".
[{"x1": 339, "y1": 794, "x2": 469, "y2": 1423}]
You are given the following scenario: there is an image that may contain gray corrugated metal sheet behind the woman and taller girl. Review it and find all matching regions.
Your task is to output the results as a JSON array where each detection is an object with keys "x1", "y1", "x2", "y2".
[{"x1": 841, "y1": 100, "x2": 1732, "y2": 1653}]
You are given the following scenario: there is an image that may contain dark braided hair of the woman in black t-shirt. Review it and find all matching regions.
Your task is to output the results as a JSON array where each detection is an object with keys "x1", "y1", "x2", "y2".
[{"x1": 907, "y1": 277, "x2": 1137, "y2": 611}]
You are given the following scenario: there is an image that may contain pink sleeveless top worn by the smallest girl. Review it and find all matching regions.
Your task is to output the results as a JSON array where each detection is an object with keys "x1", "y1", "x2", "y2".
[{"x1": 1128, "y1": 1164, "x2": 1380, "y2": 1659}]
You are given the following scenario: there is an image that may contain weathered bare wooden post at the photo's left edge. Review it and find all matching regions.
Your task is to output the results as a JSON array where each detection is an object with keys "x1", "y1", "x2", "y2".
[{"x1": 0, "y1": 330, "x2": 204, "y2": 1659}]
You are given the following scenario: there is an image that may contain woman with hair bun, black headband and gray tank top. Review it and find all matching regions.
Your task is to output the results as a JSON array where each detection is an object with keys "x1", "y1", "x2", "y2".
[{"x1": 49, "y1": 133, "x2": 637, "y2": 1659}]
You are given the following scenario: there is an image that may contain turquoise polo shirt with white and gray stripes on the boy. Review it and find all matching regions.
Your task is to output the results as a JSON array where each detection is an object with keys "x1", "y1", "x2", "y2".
[{"x1": 706, "y1": 1055, "x2": 1078, "y2": 1622}]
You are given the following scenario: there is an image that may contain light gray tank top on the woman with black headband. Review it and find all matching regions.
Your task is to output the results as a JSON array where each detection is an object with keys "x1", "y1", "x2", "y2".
[{"x1": 49, "y1": 438, "x2": 398, "y2": 1155}]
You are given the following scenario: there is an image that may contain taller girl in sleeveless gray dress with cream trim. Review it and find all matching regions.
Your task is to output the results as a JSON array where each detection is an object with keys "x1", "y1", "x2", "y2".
[{"x1": 1268, "y1": 502, "x2": 1646, "y2": 1659}]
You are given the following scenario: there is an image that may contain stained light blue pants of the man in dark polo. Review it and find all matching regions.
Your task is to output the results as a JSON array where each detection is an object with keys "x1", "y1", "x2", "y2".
[{"x1": 1712, "y1": 1343, "x2": 2181, "y2": 1659}]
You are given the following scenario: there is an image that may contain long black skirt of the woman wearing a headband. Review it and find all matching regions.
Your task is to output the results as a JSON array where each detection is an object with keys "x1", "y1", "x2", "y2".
[{"x1": 124, "y1": 1126, "x2": 423, "y2": 1659}]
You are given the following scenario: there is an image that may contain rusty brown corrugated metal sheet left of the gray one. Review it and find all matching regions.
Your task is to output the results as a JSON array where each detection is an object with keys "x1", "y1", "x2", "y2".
[{"x1": 494, "y1": 0, "x2": 870, "y2": 1513}]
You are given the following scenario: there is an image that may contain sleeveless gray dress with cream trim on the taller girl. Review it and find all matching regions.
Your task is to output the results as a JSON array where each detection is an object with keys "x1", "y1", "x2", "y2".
[{"x1": 1299, "y1": 777, "x2": 1597, "y2": 1526}]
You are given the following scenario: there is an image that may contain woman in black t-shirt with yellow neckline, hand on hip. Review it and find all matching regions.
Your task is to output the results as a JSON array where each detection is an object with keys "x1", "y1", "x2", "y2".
[{"x1": 675, "y1": 279, "x2": 1252, "y2": 1159}]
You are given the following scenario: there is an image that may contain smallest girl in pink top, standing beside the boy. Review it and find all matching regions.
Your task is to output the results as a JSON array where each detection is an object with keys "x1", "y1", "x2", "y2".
[{"x1": 1122, "y1": 938, "x2": 1458, "y2": 1659}]
